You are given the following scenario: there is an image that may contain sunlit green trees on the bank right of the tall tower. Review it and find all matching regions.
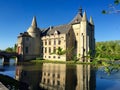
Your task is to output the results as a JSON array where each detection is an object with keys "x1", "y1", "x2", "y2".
[{"x1": 95, "y1": 40, "x2": 120, "y2": 60}]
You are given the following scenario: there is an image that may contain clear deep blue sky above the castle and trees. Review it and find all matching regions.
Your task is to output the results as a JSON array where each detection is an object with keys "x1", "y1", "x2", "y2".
[{"x1": 0, "y1": 0, "x2": 120, "y2": 50}]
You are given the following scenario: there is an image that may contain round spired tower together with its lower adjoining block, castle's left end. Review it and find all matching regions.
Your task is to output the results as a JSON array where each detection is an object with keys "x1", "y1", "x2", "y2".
[{"x1": 18, "y1": 17, "x2": 41, "y2": 60}]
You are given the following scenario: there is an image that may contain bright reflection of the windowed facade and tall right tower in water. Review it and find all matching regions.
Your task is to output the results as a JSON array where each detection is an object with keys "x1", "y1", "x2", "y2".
[{"x1": 40, "y1": 63, "x2": 96, "y2": 90}]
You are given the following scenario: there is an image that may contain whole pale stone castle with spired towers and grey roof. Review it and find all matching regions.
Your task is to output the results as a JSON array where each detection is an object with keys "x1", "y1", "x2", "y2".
[{"x1": 17, "y1": 8, "x2": 95, "y2": 62}]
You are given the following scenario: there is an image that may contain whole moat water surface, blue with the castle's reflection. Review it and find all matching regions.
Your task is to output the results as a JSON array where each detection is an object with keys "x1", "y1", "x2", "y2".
[{"x1": 0, "y1": 59, "x2": 120, "y2": 90}]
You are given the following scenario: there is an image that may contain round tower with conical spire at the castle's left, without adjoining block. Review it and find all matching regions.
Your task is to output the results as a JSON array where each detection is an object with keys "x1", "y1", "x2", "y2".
[{"x1": 27, "y1": 16, "x2": 41, "y2": 57}]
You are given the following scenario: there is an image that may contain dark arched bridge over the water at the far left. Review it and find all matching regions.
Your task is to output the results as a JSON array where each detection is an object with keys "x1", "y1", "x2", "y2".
[{"x1": 0, "y1": 52, "x2": 22, "y2": 65}]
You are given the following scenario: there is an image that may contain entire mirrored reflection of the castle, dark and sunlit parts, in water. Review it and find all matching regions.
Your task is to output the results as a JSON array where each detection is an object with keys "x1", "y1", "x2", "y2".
[{"x1": 16, "y1": 63, "x2": 96, "y2": 90}]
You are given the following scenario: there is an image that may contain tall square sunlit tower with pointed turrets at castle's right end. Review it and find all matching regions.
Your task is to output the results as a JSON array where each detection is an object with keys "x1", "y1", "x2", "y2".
[{"x1": 71, "y1": 8, "x2": 95, "y2": 62}]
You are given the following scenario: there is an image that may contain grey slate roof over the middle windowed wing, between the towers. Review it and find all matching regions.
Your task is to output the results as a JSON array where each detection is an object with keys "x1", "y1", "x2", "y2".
[{"x1": 42, "y1": 24, "x2": 71, "y2": 36}]
